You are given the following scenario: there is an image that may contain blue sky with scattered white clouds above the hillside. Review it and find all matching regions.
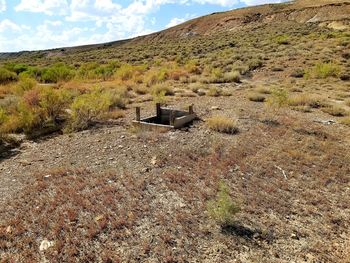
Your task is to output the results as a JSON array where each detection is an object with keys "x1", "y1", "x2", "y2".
[{"x1": 0, "y1": 0, "x2": 285, "y2": 52}]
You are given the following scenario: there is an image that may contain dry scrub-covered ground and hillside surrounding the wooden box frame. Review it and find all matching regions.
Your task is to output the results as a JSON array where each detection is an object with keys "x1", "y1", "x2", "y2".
[{"x1": 0, "y1": 0, "x2": 350, "y2": 263}]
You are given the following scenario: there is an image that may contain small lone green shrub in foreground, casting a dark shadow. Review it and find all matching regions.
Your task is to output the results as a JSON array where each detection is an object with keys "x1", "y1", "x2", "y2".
[{"x1": 207, "y1": 182, "x2": 240, "y2": 226}]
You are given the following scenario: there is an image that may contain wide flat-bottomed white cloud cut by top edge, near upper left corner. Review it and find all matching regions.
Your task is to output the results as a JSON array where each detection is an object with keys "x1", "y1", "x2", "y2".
[{"x1": 15, "y1": 0, "x2": 68, "y2": 15}]
